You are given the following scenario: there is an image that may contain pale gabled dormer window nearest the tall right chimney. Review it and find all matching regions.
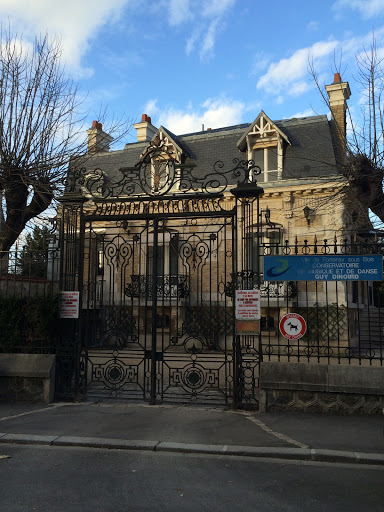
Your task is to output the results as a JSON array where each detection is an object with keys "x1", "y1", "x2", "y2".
[{"x1": 237, "y1": 111, "x2": 289, "y2": 183}]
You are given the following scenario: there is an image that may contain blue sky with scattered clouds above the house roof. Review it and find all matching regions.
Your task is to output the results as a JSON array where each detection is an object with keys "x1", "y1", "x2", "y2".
[{"x1": 0, "y1": 0, "x2": 384, "y2": 146}]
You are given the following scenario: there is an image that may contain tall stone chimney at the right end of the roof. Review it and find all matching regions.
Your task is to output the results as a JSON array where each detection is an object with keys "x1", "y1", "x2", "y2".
[{"x1": 325, "y1": 73, "x2": 351, "y2": 160}]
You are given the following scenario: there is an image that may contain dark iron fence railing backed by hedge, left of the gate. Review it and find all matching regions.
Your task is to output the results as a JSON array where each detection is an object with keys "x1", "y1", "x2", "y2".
[{"x1": 0, "y1": 249, "x2": 59, "y2": 353}]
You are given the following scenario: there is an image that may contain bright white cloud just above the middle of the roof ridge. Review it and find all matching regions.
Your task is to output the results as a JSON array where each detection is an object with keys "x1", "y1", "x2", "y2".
[{"x1": 144, "y1": 98, "x2": 248, "y2": 134}]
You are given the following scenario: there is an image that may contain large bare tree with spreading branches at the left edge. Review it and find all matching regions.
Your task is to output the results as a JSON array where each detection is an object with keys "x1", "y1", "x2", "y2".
[{"x1": 0, "y1": 29, "x2": 131, "y2": 258}]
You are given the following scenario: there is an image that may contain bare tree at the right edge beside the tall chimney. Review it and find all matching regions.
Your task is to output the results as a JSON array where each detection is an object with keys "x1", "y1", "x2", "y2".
[{"x1": 309, "y1": 35, "x2": 384, "y2": 223}]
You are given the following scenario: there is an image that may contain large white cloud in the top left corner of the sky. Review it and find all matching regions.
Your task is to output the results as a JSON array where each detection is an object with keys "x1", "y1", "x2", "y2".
[{"x1": 0, "y1": 0, "x2": 131, "y2": 76}]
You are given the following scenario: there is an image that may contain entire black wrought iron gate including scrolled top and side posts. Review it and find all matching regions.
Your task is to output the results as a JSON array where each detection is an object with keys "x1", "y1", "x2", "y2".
[{"x1": 62, "y1": 161, "x2": 259, "y2": 405}]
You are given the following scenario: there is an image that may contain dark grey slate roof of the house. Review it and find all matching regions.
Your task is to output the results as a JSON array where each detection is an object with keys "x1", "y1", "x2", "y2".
[{"x1": 76, "y1": 115, "x2": 338, "y2": 190}]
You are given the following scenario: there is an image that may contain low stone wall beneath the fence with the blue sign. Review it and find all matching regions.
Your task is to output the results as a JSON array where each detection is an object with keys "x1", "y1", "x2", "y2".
[{"x1": 260, "y1": 362, "x2": 384, "y2": 414}]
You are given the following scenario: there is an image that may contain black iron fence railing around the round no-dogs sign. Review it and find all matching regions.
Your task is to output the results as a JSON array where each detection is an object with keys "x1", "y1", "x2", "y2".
[{"x1": 261, "y1": 240, "x2": 384, "y2": 366}]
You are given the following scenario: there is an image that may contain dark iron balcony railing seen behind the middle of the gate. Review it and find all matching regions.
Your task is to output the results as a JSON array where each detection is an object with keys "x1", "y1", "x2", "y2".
[{"x1": 124, "y1": 275, "x2": 189, "y2": 300}]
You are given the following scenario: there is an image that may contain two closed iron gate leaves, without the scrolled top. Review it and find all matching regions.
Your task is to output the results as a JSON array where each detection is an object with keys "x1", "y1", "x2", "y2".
[{"x1": 81, "y1": 206, "x2": 235, "y2": 404}]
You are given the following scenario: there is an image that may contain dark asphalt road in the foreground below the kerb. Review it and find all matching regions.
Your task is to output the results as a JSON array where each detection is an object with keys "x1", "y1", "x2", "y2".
[{"x1": 0, "y1": 445, "x2": 384, "y2": 512}]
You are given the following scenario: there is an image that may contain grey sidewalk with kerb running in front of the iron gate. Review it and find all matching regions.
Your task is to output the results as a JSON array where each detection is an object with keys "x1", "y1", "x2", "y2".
[{"x1": 0, "y1": 403, "x2": 384, "y2": 465}]
